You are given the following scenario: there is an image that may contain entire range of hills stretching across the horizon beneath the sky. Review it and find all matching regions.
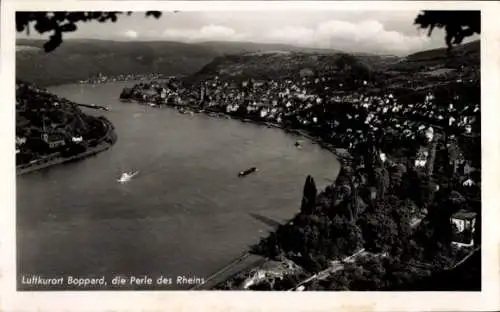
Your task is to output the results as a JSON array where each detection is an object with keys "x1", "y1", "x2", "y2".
[{"x1": 16, "y1": 39, "x2": 480, "y2": 86}]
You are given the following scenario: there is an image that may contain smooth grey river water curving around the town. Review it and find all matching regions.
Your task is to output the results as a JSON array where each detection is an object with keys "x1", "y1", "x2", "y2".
[{"x1": 17, "y1": 82, "x2": 339, "y2": 289}]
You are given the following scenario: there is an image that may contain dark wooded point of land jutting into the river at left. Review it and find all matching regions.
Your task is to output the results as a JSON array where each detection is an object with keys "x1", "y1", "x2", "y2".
[{"x1": 16, "y1": 81, "x2": 117, "y2": 174}]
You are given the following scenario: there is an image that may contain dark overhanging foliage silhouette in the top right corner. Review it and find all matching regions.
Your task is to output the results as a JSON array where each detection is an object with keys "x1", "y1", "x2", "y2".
[{"x1": 414, "y1": 10, "x2": 481, "y2": 50}]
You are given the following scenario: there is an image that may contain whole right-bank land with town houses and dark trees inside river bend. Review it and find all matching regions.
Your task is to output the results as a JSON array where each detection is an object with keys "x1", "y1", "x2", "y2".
[{"x1": 115, "y1": 51, "x2": 481, "y2": 290}]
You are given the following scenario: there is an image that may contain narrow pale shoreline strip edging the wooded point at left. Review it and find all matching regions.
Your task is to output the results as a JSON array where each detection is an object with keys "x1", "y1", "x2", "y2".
[{"x1": 16, "y1": 117, "x2": 118, "y2": 176}]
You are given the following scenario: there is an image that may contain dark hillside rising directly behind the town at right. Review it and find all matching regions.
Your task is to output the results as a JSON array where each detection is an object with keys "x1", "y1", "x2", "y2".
[{"x1": 187, "y1": 41, "x2": 480, "y2": 89}]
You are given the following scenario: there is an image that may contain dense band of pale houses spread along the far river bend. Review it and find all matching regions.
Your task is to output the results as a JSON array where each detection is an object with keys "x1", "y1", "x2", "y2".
[{"x1": 122, "y1": 75, "x2": 480, "y2": 256}]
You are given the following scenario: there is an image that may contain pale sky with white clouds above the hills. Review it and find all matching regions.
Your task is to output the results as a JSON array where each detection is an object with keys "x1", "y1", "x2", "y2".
[{"x1": 17, "y1": 10, "x2": 477, "y2": 55}]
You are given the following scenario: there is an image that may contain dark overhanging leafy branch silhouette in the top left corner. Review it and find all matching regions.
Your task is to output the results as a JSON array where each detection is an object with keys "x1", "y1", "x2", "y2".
[{"x1": 16, "y1": 11, "x2": 161, "y2": 52}]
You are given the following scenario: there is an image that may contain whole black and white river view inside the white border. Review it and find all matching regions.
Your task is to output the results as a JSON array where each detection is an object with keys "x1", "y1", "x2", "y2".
[{"x1": 2, "y1": 1, "x2": 498, "y2": 310}]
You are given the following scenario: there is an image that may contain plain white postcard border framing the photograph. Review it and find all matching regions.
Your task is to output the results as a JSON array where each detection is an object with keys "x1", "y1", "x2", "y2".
[{"x1": 0, "y1": 0, "x2": 500, "y2": 311}]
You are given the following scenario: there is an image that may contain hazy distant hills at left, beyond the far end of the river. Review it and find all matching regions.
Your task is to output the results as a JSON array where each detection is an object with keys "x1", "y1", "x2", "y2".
[{"x1": 16, "y1": 39, "x2": 342, "y2": 86}]
